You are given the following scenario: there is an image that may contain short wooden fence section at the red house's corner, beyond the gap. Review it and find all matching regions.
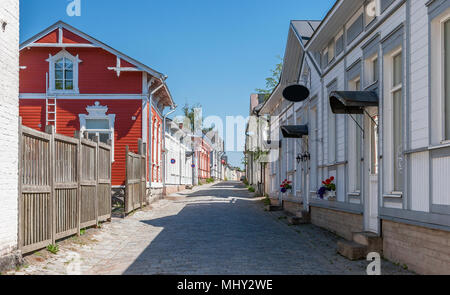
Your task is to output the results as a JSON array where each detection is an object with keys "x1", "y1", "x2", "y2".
[{"x1": 125, "y1": 141, "x2": 147, "y2": 214}]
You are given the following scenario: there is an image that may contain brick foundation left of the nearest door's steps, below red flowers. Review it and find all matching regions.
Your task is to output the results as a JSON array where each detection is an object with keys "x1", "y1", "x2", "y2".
[{"x1": 311, "y1": 206, "x2": 363, "y2": 240}]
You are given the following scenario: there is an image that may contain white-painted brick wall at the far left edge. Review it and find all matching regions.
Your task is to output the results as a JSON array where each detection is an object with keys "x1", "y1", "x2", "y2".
[{"x1": 0, "y1": 0, "x2": 19, "y2": 259}]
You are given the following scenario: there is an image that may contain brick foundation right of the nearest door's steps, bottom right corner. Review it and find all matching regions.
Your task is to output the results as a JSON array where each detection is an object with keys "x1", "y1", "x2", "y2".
[{"x1": 382, "y1": 220, "x2": 450, "y2": 275}]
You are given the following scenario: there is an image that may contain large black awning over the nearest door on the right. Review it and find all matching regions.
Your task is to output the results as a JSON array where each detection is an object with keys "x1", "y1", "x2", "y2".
[{"x1": 330, "y1": 91, "x2": 379, "y2": 114}]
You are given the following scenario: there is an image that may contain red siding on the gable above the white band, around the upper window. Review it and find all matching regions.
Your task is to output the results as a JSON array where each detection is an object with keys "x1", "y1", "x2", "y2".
[{"x1": 20, "y1": 48, "x2": 142, "y2": 94}]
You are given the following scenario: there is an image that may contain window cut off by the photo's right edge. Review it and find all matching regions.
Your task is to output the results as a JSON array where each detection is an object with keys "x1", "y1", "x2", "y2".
[{"x1": 443, "y1": 19, "x2": 450, "y2": 140}]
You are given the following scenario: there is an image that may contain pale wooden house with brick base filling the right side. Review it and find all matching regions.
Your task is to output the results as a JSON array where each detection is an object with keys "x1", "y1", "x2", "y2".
[{"x1": 261, "y1": 0, "x2": 450, "y2": 274}]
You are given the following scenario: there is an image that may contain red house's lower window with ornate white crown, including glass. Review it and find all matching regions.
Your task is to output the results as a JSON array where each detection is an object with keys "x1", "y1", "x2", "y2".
[{"x1": 78, "y1": 101, "x2": 116, "y2": 161}]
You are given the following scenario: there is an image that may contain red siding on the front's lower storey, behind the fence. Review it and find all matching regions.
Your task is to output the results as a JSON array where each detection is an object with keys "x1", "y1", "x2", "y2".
[{"x1": 20, "y1": 99, "x2": 142, "y2": 186}]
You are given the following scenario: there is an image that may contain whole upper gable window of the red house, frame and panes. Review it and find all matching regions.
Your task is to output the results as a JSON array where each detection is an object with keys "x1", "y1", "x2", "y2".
[{"x1": 47, "y1": 50, "x2": 81, "y2": 93}]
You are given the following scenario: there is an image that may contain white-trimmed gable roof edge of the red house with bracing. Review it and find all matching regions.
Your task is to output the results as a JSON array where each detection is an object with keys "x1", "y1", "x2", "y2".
[{"x1": 19, "y1": 21, "x2": 174, "y2": 105}]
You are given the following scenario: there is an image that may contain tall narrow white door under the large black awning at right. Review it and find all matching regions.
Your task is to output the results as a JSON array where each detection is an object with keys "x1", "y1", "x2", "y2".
[{"x1": 364, "y1": 108, "x2": 379, "y2": 233}]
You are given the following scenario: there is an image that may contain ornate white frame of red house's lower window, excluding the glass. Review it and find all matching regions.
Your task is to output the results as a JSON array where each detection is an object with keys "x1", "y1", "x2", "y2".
[{"x1": 78, "y1": 101, "x2": 116, "y2": 162}]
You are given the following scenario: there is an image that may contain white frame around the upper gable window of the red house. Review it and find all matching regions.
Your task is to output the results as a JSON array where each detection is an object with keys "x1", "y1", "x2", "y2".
[{"x1": 46, "y1": 49, "x2": 83, "y2": 94}]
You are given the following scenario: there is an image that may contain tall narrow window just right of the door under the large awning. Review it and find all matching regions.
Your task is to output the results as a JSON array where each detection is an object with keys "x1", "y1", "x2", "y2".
[{"x1": 391, "y1": 52, "x2": 403, "y2": 192}]
